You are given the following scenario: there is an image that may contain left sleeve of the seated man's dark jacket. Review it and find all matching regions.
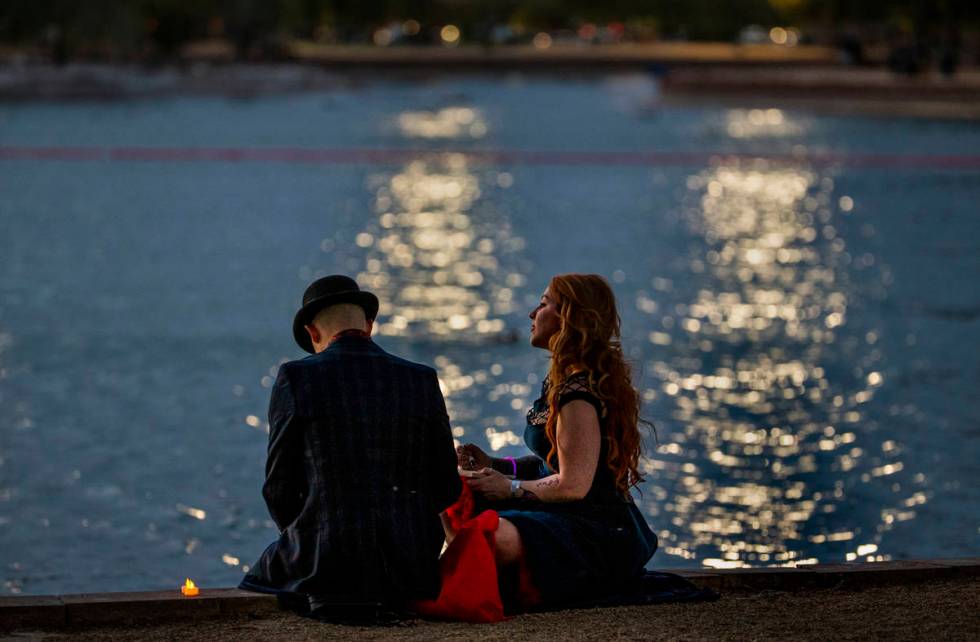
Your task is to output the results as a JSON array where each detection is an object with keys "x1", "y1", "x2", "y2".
[{"x1": 262, "y1": 367, "x2": 307, "y2": 532}]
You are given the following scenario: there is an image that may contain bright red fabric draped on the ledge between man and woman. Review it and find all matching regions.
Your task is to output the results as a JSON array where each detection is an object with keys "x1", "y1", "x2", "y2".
[{"x1": 412, "y1": 479, "x2": 540, "y2": 622}]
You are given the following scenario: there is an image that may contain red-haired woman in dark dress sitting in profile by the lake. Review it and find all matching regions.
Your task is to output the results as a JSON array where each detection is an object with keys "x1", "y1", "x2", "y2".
[{"x1": 460, "y1": 274, "x2": 657, "y2": 606}]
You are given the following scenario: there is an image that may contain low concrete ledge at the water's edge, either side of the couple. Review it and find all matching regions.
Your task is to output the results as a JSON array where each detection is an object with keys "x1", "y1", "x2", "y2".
[{"x1": 0, "y1": 557, "x2": 980, "y2": 631}]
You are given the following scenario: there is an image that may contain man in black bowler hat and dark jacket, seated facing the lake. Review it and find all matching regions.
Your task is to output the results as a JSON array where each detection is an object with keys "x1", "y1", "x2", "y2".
[{"x1": 241, "y1": 275, "x2": 461, "y2": 621}]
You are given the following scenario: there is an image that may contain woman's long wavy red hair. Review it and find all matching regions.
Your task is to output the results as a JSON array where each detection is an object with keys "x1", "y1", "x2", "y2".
[{"x1": 545, "y1": 274, "x2": 643, "y2": 493}]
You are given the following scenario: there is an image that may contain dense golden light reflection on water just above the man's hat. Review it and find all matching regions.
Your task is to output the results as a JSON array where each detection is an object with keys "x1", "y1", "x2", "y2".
[{"x1": 356, "y1": 154, "x2": 525, "y2": 340}]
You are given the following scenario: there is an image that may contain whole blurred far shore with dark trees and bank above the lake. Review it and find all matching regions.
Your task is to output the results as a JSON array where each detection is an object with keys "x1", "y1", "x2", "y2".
[{"x1": 0, "y1": 0, "x2": 980, "y2": 120}]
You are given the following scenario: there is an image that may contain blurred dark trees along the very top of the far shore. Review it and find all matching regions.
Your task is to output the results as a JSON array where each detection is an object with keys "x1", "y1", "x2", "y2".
[{"x1": 0, "y1": 0, "x2": 980, "y2": 60}]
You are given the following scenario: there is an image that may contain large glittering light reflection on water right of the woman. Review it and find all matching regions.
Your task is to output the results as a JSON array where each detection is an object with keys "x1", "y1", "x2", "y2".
[{"x1": 639, "y1": 162, "x2": 927, "y2": 568}]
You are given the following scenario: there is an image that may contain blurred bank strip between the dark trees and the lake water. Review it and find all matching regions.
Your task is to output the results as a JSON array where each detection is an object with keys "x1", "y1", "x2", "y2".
[{"x1": 0, "y1": 60, "x2": 980, "y2": 121}]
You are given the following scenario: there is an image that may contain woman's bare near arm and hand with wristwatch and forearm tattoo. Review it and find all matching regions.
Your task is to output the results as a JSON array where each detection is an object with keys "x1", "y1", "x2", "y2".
[{"x1": 467, "y1": 399, "x2": 602, "y2": 502}]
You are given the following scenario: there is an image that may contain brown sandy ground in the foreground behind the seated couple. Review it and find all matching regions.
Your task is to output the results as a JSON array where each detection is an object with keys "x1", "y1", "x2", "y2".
[{"x1": 9, "y1": 577, "x2": 980, "y2": 642}]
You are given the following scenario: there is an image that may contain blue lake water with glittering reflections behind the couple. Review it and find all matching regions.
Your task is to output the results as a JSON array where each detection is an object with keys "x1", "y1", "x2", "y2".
[{"x1": 0, "y1": 76, "x2": 980, "y2": 593}]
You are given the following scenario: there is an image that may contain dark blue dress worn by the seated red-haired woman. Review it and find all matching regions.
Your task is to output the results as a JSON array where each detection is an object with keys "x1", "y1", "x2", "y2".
[{"x1": 500, "y1": 373, "x2": 657, "y2": 606}]
